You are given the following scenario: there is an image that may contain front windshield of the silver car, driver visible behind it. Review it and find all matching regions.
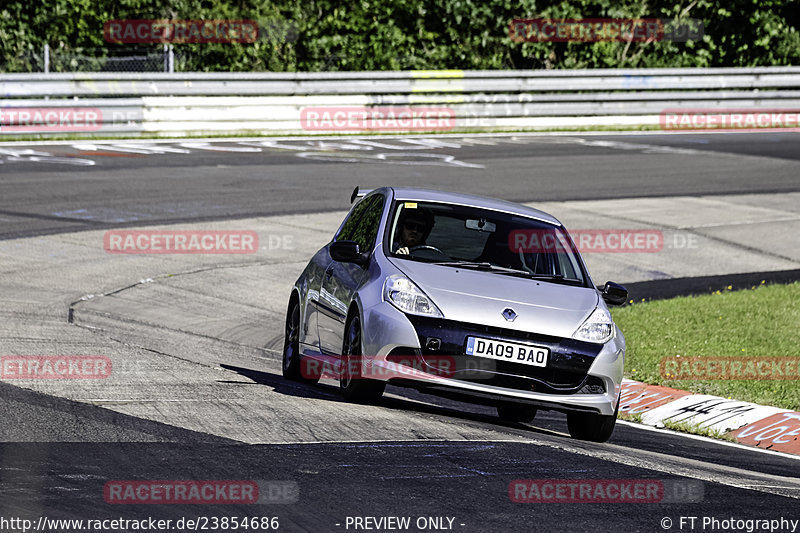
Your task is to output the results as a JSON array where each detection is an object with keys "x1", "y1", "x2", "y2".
[{"x1": 387, "y1": 201, "x2": 585, "y2": 285}]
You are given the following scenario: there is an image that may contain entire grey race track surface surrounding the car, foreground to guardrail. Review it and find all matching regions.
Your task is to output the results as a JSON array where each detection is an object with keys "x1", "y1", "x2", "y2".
[{"x1": 0, "y1": 133, "x2": 800, "y2": 533}]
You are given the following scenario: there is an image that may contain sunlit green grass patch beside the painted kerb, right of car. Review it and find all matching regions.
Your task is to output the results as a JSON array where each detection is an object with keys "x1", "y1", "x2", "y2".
[{"x1": 612, "y1": 282, "x2": 800, "y2": 410}]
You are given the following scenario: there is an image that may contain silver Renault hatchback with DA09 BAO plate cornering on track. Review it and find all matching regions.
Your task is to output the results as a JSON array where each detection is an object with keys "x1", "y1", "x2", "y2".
[{"x1": 283, "y1": 187, "x2": 628, "y2": 442}]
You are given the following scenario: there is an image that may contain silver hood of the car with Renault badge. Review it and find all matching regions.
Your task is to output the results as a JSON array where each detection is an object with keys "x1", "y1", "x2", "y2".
[{"x1": 392, "y1": 260, "x2": 599, "y2": 337}]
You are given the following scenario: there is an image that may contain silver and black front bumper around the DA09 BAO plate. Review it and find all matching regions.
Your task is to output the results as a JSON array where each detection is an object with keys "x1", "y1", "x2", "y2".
[{"x1": 363, "y1": 302, "x2": 625, "y2": 415}]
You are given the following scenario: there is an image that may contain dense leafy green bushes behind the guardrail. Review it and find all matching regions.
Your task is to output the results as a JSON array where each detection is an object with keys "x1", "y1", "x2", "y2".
[{"x1": 0, "y1": 0, "x2": 800, "y2": 72}]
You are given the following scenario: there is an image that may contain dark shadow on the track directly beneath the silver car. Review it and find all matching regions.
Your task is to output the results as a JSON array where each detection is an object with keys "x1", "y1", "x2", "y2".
[{"x1": 220, "y1": 364, "x2": 568, "y2": 438}]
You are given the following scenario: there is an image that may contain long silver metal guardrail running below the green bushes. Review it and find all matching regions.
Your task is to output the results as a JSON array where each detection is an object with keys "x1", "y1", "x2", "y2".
[{"x1": 0, "y1": 67, "x2": 800, "y2": 136}]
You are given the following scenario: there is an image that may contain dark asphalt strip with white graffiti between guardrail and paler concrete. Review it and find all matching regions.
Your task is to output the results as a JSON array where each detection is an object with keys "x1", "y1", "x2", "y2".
[{"x1": 0, "y1": 133, "x2": 800, "y2": 238}]
